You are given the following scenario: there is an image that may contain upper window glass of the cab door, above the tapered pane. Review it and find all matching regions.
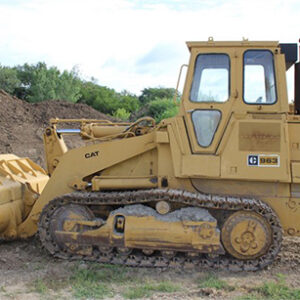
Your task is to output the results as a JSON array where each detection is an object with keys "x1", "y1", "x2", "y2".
[{"x1": 190, "y1": 54, "x2": 229, "y2": 102}]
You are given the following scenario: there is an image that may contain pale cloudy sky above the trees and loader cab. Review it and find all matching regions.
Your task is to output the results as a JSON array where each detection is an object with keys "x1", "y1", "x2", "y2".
[{"x1": 0, "y1": 0, "x2": 300, "y2": 98}]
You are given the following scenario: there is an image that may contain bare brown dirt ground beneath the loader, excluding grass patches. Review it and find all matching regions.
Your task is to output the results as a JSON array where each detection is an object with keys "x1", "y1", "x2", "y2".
[{"x1": 0, "y1": 238, "x2": 300, "y2": 300}]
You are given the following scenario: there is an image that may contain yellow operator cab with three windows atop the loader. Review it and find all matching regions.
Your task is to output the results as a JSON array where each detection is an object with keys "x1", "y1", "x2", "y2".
[{"x1": 181, "y1": 39, "x2": 300, "y2": 153}]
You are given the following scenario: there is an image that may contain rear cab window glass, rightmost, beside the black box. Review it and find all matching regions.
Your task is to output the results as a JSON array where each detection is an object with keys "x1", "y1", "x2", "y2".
[{"x1": 244, "y1": 50, "x2": 276, "y2": 104}]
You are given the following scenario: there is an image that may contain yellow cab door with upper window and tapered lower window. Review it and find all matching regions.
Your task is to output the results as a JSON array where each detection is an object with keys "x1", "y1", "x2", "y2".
[{"x1": 182, "y1": 47, "x2": 237, "y2": 155}]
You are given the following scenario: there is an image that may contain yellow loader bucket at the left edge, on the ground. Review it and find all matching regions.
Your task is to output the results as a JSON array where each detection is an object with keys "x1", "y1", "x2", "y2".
[{"x1": 0, "y1": 154, "x2": 49, "y2": 240}]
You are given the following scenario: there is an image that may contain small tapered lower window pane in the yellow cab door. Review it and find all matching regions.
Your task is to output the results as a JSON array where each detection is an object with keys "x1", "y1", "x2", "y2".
[{"x1": 192, "y1": 110, "x2": 221, "y2": 147}]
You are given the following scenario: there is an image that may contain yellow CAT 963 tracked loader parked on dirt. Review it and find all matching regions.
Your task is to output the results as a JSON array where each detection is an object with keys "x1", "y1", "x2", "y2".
[{"x1": 0, "y1": 39, "x2": 300, "y2": 270}]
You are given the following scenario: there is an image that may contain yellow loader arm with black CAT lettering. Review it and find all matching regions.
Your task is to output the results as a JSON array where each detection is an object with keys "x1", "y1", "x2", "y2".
[{"x1": 18, "y1": 131, "x2": 156, "y2": 238}]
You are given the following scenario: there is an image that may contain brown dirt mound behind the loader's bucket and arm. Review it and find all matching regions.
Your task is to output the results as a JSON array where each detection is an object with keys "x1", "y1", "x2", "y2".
[{"x1": 0, "y1": 90, "x2": 110, "y2": 167}]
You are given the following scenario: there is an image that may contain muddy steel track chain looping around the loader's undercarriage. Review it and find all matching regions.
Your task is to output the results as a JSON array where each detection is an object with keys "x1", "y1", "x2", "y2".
[{"x1": 39, "y1": 189, "x2": 282, "y2": 271}]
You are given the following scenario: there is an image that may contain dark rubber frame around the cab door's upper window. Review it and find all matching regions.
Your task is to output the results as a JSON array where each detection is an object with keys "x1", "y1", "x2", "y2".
[{"x1": 189, "y1": 52, "x2": 231, "y2": 104}]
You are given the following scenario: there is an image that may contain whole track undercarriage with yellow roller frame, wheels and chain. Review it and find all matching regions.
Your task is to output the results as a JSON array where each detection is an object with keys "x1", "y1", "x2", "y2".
[{"x1": 39, "y1": 189, "x2": 282, "y2": 271}]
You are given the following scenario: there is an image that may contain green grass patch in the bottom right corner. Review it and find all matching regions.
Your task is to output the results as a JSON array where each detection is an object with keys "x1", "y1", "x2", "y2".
[{"x1": 237, "y1": 274, "x2": 300, "y2": 300}]
